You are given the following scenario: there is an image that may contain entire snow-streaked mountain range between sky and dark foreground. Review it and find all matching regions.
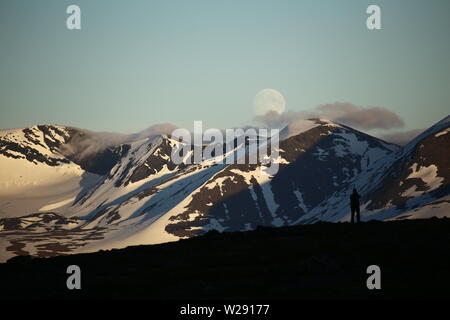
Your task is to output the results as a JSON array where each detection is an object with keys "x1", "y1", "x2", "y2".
[{"x1": 0, "y1": 117, "x2": 450, "y2": 260}]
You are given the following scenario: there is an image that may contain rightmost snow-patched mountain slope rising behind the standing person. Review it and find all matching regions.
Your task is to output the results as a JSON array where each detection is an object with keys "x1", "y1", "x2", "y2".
[{"x1": 298, "y1": 117, "x2": 450, "y2": 223}]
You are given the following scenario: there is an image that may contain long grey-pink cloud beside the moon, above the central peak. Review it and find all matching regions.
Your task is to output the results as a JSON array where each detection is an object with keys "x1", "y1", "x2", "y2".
[{"x1": 256, "y1": 102, "x2": 404, "y2": 130}]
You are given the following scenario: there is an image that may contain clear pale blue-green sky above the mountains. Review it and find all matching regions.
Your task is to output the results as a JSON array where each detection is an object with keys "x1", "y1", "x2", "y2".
[{"x1": 0, "y1": 0, "x2": 450, "y2": 133}]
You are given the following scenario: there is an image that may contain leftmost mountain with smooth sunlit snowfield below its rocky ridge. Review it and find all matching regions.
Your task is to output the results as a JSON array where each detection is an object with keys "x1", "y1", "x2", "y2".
[{"x1": 0, "y1": 125, "x2": 125, "y2": 216}]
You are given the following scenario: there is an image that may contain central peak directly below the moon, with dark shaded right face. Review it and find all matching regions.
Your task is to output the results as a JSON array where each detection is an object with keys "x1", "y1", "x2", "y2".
[{"x1": 160, "y1": 119, "x2": 398, "y2": 236}]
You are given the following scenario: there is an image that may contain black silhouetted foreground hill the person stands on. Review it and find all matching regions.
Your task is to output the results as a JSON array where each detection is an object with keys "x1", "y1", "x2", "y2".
[{"x1": 0, "y1": 218, "x2": 450, "y2": 300}]
